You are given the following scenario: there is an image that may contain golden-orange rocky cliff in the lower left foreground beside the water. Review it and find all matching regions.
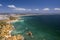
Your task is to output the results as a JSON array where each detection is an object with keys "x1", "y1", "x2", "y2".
[{"x1": 0, "y1": 22, "x2": 24, "y2": 40}]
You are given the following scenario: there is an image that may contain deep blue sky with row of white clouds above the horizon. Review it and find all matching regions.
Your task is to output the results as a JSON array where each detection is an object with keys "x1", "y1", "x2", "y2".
[{"x1": 0, "y1": 0, "x2": 60, "y2": 13}]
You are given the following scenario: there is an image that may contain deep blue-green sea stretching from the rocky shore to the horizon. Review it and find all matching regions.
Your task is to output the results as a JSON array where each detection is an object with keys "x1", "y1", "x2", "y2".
[{"x1": 12, "y1": 15, "x2": 60, "y2": 40}]
